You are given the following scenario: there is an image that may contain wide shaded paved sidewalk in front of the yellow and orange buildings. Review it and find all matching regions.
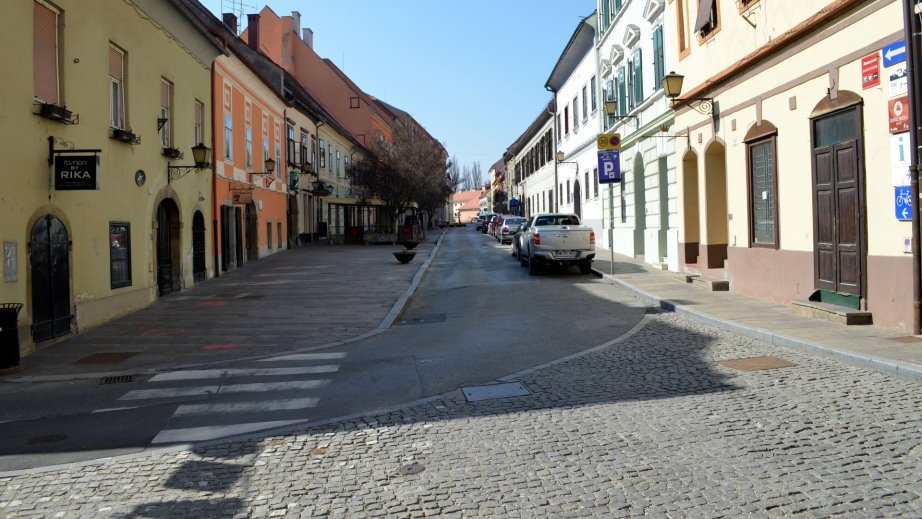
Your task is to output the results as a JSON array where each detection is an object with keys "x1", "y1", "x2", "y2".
[{"x1": 0, "y1": 236, "x2": 442, "y2": 382}]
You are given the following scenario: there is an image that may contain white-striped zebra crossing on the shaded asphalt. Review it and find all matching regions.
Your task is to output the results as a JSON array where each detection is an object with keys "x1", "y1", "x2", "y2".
[{"x1": 111, "y1": 352, "x2": 346, "y2": 445}]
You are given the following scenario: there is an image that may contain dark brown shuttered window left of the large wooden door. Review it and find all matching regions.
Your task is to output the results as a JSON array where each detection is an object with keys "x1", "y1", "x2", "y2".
[{"x1": 747, "y1": 135, "x2": 778, "y2": 248}]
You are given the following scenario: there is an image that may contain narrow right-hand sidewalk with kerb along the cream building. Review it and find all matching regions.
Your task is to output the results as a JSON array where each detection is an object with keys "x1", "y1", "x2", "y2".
[{"x1": 593, "y1": 249, "x2": 922, "y2": 380}]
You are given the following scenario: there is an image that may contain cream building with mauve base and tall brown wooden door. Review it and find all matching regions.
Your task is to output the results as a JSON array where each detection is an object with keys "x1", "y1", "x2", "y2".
[{"x1": 666, "y1": 0, "x2": 912, "y2": 330}]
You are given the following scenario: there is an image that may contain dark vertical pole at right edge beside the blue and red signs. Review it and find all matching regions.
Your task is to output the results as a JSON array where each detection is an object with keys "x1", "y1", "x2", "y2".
[{"x1": 903, "y1": 0, "x2": 922, "y2": 335}]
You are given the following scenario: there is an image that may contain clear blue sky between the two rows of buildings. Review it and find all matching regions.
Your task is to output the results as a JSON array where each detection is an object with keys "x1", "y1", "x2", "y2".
[{"x1": 201, "y1": 0, "x2": 595, "y2": 179}]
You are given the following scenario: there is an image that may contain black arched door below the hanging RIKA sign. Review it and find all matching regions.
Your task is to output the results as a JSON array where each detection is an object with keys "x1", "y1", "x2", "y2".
[{"x1": 29, "y1": 214, "x2": 72, "y2": 343}]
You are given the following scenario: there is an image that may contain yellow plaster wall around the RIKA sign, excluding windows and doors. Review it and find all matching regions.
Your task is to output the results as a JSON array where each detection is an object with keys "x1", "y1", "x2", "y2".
[{"x1": 0, "y1": 0, "x2": 218, "y2": 350}]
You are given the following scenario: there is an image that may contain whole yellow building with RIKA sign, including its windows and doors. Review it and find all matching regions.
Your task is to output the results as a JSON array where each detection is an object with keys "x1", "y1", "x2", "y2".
[{"x1": 0, "y1": 0, "x2": 221, "y2": 353}]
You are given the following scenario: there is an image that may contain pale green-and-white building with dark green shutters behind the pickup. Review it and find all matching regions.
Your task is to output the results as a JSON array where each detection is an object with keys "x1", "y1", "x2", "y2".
[{"x1": 596, "y1": 0, "x2": 679, "y2": 271}]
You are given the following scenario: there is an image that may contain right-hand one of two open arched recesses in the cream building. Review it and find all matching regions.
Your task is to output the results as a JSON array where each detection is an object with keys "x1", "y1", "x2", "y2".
[{"x1": 701, "y1": 142, "x2": 730, "y2": 268}]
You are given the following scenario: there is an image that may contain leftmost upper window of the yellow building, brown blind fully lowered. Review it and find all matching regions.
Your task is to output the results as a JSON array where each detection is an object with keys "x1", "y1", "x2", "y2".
[{"x1": 32, "y1": 1, "x2": 63, "y2": 106}]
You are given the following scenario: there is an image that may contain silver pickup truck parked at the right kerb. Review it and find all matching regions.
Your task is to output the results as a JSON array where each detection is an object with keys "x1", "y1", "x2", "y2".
[{"x1": 517, "y1": 213, "x2": 595, "y2": 275}]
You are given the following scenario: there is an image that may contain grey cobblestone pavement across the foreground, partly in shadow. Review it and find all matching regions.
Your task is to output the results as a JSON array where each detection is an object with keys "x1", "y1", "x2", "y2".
[{"x1": 0, "y1": 314, "x2": 922, "y2": 518}]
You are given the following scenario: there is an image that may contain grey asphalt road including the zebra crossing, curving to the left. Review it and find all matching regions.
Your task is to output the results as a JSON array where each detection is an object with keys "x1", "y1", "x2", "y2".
[{"x1": 0, "y1": 227, "x2": 645, "y2": 471}]
